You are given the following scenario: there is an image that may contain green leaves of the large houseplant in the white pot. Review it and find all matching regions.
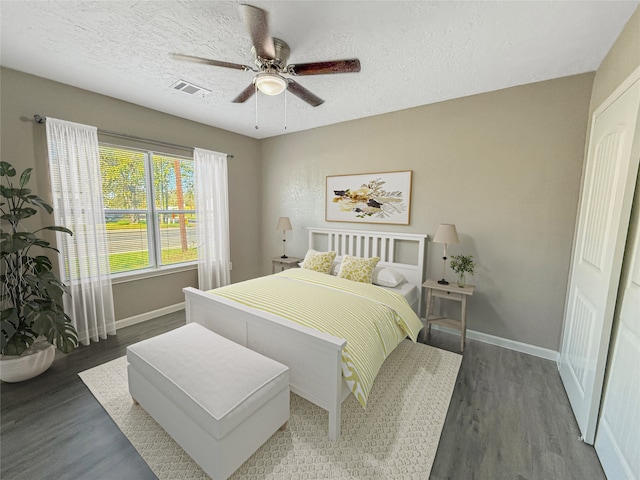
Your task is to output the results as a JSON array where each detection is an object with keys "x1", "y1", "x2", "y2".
[{"x1": 0, "y1": 162, "x2": 78, "y2": 364}]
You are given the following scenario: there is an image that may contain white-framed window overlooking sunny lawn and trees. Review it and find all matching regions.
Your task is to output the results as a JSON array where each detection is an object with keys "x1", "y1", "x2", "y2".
[{"x1": 100, "y1": 144, "x2": 197, "y2": 273}]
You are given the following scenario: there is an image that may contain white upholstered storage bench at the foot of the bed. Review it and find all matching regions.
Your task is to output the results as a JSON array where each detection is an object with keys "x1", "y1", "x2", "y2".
[{"x1": 127, "y1": 323, "x2": 289, "y2": 480}]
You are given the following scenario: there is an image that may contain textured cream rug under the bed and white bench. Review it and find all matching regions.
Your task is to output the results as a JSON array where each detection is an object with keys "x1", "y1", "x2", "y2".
[{"x1": 79, "y1": 340, "x2": 462, "y2": 480}]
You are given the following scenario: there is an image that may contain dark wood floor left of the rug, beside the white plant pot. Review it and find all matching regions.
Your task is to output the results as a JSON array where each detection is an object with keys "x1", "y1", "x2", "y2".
[{"x1": 0, "y1": 312, "x2": 185, "y2": 480}]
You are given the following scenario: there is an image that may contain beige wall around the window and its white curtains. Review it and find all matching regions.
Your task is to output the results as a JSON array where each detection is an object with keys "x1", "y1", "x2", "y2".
[{"x1": 0, "y1": 68, "x2": 262, "y2": 320}]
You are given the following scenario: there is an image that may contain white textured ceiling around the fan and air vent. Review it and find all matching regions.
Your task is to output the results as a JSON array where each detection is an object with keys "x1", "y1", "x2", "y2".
[{"x1": 0, "y1": 0, "x2": 640, "y2": 138}]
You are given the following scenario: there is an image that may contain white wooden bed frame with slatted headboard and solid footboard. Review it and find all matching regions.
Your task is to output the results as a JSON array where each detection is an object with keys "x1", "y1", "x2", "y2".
[{"x1": 184, "y1": 228, "x2": 427, "y2": 440}]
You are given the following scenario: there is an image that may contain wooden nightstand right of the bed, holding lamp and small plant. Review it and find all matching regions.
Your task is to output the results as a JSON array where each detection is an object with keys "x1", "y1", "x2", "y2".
[{"x1": 422, "y1": 280, "x2": 476, "y2": 352}]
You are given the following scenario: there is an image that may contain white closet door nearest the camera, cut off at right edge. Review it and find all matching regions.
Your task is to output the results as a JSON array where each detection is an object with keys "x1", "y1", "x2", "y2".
[{"x1": 595, "y1": 186, "x2": 640, "y2": 479}]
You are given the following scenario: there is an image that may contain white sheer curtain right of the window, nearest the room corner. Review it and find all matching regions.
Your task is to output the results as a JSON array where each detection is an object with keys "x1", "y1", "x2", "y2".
[{"x1": 193, "y1": 148, "x2": 231, "y2": 290}]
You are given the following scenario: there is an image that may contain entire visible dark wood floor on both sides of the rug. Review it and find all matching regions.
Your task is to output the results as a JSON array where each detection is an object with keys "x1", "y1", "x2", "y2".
[{"x1": 0, "y1": 312, "x2": 605, "y2": 480}]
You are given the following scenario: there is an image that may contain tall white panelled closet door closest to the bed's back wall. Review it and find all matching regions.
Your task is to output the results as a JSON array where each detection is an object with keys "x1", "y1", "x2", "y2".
[{"x1": 558, "y1": 69, "x2": 640, "y2": 444}]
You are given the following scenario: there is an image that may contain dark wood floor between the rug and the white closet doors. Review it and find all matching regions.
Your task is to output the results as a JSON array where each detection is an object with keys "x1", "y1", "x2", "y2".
[{"x1": 426, "y1": 332, "x2": 606, "y2": 480}]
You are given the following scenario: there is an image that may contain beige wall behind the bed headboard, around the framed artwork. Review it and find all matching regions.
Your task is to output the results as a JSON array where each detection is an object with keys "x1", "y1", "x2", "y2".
[{"x1": 261, "y1": 73, "x2": 593, "y2": 350}]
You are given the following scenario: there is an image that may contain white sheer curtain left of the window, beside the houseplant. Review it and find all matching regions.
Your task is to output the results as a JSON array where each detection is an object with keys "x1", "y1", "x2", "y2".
[{"x1": 47, "y1": 118, "x2": 116, "y2": 345}]
